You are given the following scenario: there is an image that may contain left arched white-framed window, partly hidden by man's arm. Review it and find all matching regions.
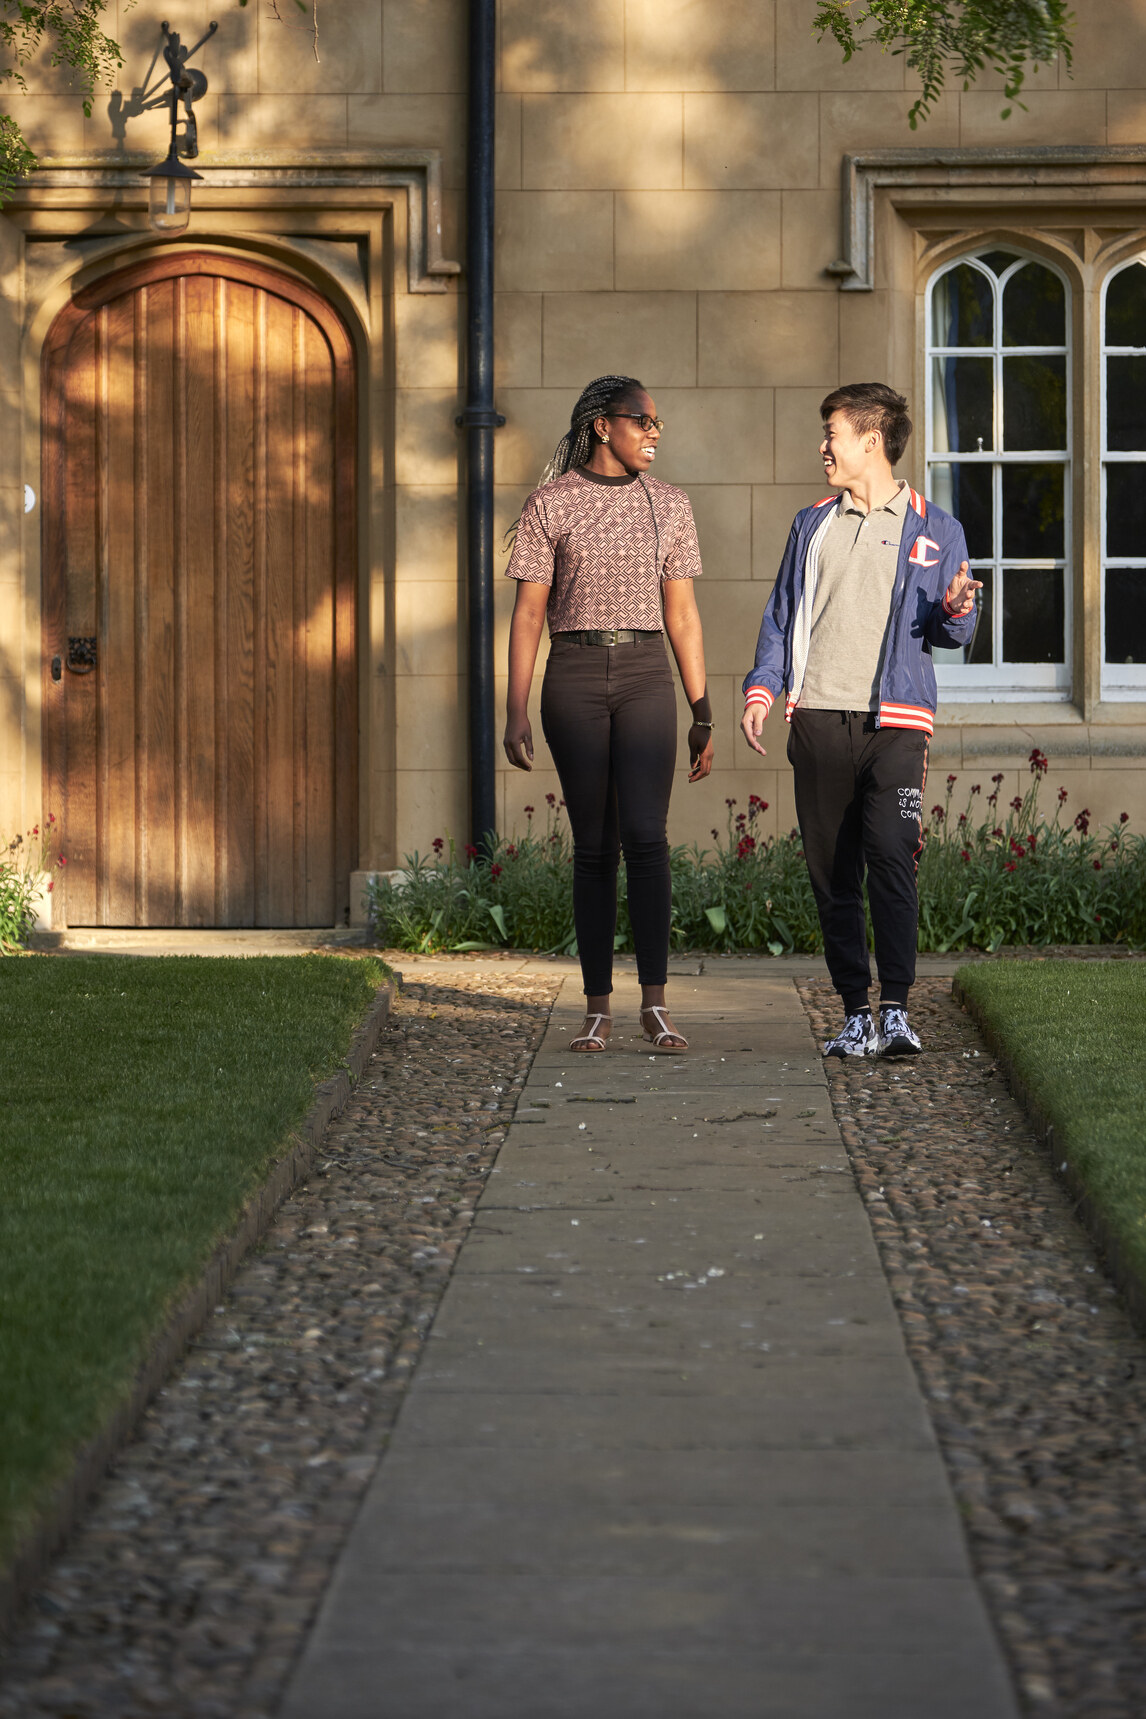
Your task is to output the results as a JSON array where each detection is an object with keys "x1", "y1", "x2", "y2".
[{"x1": 924, "y1": 249, "x2": 1072, "y2": 700}]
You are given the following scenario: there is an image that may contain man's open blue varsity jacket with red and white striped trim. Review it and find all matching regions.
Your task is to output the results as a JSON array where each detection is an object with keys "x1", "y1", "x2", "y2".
[{"x1": 744, "y1": 488, "x2": 974, "y2": 734}]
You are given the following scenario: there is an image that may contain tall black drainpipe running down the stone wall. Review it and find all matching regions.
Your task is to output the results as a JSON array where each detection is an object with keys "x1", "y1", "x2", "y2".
[{"x1": 457, "y1": 0, "x2": 505, "y2": 847}]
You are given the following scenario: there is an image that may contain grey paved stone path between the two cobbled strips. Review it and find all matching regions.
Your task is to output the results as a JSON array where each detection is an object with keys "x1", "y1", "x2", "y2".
[{"x1": 282, "y1": 966, "x2": 1017, "y2": 1719}]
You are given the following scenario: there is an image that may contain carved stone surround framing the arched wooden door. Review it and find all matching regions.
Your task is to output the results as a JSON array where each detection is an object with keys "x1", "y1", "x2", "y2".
[{"x1": 0, "y1": 148, "x2": 460, "y2": 866}]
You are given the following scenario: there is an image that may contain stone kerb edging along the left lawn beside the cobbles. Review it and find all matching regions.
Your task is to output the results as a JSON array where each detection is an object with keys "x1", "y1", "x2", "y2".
[{"x1": 0, "y1": 973, "x2": 402, "y2": 1630}]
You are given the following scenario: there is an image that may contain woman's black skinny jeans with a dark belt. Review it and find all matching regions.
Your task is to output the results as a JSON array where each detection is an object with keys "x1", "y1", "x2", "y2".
[{"x1": 541, "y1": 633, "x2": 677, "y2": 997}]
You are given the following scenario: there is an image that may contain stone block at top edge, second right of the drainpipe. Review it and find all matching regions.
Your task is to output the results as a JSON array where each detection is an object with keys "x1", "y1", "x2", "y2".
[{"x1": 625, "y1": 0, "x2": 775, "y2": 89}]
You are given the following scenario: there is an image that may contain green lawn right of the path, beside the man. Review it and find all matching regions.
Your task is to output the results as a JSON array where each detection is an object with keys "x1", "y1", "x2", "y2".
[{"x1": 959, "y1": 961, "x2": 1146, "y2": 1284}]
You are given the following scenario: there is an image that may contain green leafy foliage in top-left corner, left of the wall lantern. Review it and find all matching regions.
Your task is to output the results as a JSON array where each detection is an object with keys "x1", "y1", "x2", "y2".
[{"x1": 0, "y1": 0, "x2": 124, "y2": 197}]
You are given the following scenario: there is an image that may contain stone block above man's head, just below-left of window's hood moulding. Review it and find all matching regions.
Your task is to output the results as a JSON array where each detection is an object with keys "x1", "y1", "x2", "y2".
[{"x1": 698, "y1": 292, "x2": 838, "y2": 392}]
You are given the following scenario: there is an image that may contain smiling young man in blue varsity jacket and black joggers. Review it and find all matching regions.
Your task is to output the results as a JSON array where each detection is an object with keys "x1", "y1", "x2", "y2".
[{"x1": 741, "y1": 382, "x2": 979, "y2": 1057}]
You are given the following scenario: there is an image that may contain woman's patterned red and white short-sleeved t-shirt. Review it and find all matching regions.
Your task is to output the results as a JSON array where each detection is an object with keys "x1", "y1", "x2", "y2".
[{"x1": 505, "y1": 468, "x2": 701, "y2": 633}]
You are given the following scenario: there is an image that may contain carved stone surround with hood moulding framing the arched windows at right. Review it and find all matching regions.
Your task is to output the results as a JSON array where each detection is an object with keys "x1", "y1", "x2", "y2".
[{"x1": 828, "y1": 146, "x2": 1146, "y2": 725}]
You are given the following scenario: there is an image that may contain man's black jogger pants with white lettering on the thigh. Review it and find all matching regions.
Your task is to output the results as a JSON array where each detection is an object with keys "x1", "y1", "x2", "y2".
[{"x1": 789, "y1": 708, "x2": 928, "y2": 1014}]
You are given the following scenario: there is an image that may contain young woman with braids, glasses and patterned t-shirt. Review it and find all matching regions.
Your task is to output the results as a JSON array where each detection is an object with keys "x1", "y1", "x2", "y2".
[{"x1": 505, "y1": 376, "x2": 713, "y2": 1052}]
